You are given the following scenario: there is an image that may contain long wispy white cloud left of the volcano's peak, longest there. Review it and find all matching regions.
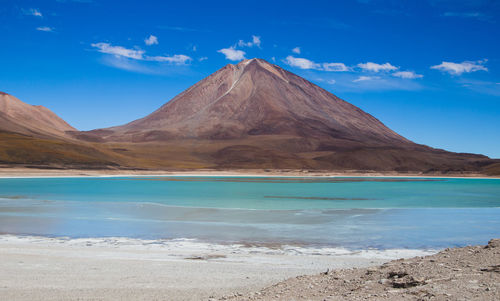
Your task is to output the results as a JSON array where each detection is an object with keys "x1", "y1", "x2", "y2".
[{"x1": 91, "y1": 43, "x2": 192, "y2": 65}]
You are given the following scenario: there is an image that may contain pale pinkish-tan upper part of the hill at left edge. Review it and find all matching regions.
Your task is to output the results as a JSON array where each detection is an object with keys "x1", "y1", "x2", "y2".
[{"x1": 0, "y1": 92, "x2": 76, "y2": 137}]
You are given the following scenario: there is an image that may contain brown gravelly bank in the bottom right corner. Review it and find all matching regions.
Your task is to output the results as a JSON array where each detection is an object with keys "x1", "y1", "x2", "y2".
[{"x1": 220, "y1": 239, "x2": 500, "y2": 300}]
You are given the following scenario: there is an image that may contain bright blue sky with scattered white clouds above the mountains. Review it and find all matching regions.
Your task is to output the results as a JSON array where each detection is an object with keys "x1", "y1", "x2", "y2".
[{"x1": 0, "y1": 0, "x2": 500, "y2": 158}]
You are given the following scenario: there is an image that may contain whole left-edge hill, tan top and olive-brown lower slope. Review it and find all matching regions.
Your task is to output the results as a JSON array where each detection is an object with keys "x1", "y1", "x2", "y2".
[{"x1": 0, "y1": 92, "x2": 118, "y2": 168}]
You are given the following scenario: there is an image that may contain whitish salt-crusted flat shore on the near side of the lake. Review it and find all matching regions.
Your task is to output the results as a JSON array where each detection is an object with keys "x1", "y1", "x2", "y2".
[{"x1": 0, "y1": 235, "x2": 431, "y2": 300}]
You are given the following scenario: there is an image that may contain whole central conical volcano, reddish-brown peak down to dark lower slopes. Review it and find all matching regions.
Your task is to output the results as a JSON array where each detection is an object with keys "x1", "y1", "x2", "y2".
[{"x1": 69, "y1": 59, "x2": 488, "y2": 171}]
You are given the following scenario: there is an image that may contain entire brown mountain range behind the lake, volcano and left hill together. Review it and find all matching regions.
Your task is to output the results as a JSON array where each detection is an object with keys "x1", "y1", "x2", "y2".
[{"x1": 0, "y1": 59, "x2": 500, "y2": 175}]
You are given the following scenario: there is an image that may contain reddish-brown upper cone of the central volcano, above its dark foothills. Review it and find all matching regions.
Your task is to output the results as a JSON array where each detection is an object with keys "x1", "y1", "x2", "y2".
[{"x1": 97, "y1": 59, "x2": 408, "y2": 144}]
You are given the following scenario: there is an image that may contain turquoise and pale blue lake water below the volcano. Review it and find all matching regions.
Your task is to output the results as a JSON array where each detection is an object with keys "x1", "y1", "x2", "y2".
[{"x1": 0, "y1": 176, "x2": 500, "y2": 249}]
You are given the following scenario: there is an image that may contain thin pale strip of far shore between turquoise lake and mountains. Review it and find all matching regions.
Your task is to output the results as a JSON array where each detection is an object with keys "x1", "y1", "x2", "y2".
[{"x1": 0, "y1": 166, "x2": 494, "y2": 178}]
